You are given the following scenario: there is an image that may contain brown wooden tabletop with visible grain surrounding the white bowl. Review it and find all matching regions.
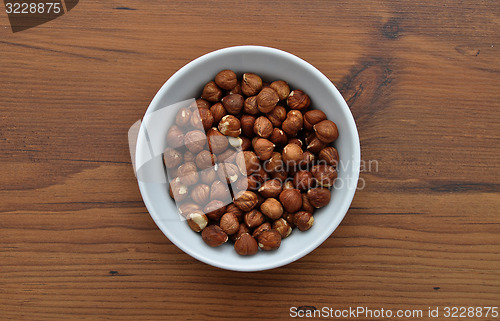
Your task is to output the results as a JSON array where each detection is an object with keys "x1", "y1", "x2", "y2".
[{"x1": 0, "y1": 0, "x2": 500, "y2": 320}]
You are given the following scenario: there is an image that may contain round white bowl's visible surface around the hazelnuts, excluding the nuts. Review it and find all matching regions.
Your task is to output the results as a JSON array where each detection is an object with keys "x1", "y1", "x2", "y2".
[{"x1": 135, "y1": 46, "x2": 360, "y2": 271}]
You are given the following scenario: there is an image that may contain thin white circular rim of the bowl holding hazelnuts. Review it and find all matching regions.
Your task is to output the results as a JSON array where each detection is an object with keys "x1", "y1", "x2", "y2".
[{"x1": 135, "y1": 45, "x2": 361, "y2": 272}]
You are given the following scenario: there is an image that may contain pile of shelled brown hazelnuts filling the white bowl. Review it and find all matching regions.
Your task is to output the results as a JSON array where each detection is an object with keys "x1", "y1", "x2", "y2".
[{"x1": 163, "y1": 70, "x2": 339, "y2": 255}]
